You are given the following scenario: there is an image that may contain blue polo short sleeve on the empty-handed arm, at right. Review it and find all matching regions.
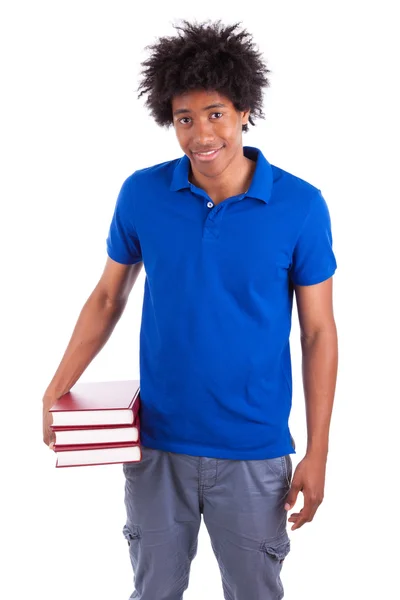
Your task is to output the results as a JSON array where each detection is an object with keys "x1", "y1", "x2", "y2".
[{"x1": 290, "y1": 190, "x2": 337, "y2": 285}]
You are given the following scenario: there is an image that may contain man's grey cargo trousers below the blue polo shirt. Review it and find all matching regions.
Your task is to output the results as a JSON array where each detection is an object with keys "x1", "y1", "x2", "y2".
[{"x1": 123, "y1": 446, "x2": 292, "y2": 600}]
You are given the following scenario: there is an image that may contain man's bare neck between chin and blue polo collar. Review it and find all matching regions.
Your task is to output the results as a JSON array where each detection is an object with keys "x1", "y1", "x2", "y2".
[{"x1": 189, "y1": 148, "x2": 256, "y2": 204}]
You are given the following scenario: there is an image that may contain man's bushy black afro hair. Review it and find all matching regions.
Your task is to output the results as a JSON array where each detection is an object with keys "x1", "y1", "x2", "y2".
[{"x1": 137, "y1": 20, "x2": 270, "y2": 131}]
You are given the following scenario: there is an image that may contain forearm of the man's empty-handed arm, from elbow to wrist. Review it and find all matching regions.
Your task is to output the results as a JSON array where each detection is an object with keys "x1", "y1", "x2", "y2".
[{"x1": 301, "y1": 324, "x2": 338, "y2": 456}]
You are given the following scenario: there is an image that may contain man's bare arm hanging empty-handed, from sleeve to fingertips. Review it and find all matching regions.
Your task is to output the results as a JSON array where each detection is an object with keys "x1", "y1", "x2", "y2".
[{"x1": 285, "y1": 278, "x2": 338, "y2": 530}]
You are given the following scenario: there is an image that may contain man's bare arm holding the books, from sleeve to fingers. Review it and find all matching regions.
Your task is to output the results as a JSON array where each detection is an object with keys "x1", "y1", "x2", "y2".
[{"x1": 43, "y1": 257, "x2": 143, "y2": 444}]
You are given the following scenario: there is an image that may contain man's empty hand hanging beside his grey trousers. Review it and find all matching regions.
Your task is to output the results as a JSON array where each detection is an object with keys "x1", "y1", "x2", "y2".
[{"x1": 285, "y1": 454, "x2": 326, "y2": 531}]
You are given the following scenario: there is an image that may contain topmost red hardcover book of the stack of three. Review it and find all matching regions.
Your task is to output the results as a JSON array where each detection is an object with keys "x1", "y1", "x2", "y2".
[{"x1": 50, "y1": 380, "x2": 140, "y2": 429}]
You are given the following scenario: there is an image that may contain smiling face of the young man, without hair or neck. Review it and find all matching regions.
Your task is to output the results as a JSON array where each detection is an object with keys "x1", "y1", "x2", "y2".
[{"x1": 172, "y1": 90, "x2": 249, "y2": 176}]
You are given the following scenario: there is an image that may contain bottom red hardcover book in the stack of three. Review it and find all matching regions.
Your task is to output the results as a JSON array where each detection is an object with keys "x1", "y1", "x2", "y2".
[{"x1": 54, "y1": 442, "x2": 142, "y2": 467}]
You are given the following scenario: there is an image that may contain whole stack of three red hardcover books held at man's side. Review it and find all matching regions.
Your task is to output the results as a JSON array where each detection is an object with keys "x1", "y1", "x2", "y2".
[{"x1": 50, "y1": 380, "x2": 142, "y2": 467}]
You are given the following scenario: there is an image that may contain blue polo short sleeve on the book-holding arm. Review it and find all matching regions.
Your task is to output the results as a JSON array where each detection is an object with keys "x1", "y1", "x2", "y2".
[{"x1": 106, "y1": 174, "x2": 142, "y2": 265}]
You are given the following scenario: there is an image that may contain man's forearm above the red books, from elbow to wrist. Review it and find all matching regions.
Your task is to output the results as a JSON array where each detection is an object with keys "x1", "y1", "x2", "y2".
[{"x1": 44, "y1": 291, "x2": 124, "y2": 402}]
